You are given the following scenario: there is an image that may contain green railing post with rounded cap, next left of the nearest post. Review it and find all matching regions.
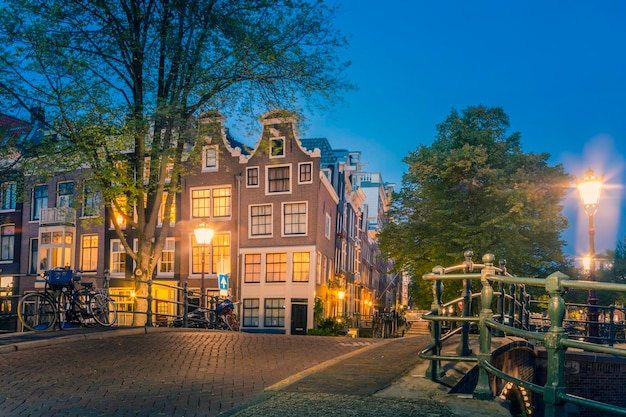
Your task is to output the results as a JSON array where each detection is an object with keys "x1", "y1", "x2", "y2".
[{"x1": 474, "y1": 253, "x2": 496, "y2": 400}]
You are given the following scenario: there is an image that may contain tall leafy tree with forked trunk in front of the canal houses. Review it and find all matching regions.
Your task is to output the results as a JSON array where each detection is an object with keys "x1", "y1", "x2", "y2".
[{"x1": 0, "y1": 0, "x2": 351, "y2": 322}]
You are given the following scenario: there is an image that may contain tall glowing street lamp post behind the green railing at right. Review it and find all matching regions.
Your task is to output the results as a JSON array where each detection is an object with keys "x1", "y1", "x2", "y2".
[{"x1": 577, "y1": 169, "x2": 603, "y2": 342}]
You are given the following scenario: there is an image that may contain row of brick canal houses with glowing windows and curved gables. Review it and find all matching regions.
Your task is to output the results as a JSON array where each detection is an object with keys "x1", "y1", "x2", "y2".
[{"x1": 0, "y1": 111, "x2": 392, "y2": 334}]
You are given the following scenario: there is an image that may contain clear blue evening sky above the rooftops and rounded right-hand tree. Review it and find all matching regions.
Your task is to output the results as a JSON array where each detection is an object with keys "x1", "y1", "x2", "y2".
[{"x1": 303, "y1": 0, "x2": 626, "y2": 256}]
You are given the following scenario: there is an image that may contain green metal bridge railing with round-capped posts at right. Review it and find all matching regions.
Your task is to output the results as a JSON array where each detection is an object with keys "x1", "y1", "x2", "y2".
[{"x1": 420, "y1": 252, "x2": 626, "y2": 417}]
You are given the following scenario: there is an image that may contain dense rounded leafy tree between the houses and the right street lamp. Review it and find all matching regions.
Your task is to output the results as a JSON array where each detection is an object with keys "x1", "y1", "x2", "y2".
[{"x1": 380, "y1": 106, "x2": 570, "y2": 306}]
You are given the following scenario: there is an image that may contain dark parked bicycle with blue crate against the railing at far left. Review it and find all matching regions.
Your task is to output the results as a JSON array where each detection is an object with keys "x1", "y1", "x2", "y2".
[{"x1": 17, "y1": 269, "x2": 117, "y2": 330}]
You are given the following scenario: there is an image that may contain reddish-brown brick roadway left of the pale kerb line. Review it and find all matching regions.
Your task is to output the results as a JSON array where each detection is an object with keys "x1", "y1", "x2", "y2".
[{"x1": 0, "y1": 329, "x2": 384, "y2": 417}]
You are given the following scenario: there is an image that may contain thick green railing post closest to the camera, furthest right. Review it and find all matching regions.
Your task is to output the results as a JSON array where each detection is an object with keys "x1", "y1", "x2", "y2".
[{"x1": 543, "y1": 272, "x2": 568, "y2": 417}]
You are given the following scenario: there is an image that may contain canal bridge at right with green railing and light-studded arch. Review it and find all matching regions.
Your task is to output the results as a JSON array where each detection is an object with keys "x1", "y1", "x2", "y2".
[{"x1": 1, "y1": 253, "x2": 626, "y2": 417}]
